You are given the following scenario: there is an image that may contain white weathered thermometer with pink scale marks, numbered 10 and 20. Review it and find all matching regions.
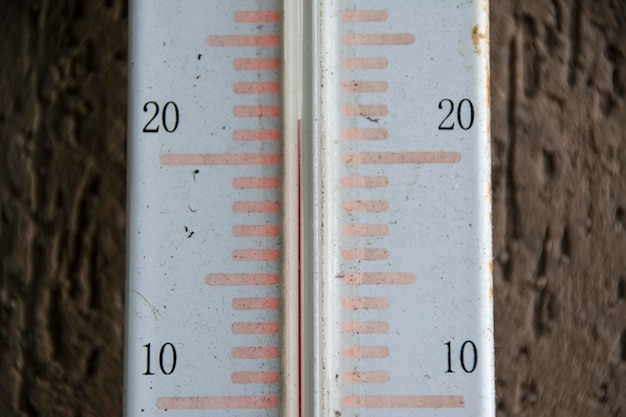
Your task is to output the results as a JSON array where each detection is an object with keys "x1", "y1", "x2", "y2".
[{"x1": 125, "y1": 0, "x2": 495, "y2": 417}]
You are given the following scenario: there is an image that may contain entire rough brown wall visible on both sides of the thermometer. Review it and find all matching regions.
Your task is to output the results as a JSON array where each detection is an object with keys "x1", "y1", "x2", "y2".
[{"x1": 0, "y1": 0, "x2": 626, "y2": 417}]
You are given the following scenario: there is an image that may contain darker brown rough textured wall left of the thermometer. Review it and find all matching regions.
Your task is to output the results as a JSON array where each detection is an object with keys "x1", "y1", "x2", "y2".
[{"x1": 0, "y1": 0, "x2": 127, "y2": 417}]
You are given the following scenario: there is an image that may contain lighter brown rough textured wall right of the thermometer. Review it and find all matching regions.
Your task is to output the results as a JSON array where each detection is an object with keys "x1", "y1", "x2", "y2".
[{"x1": 491, "y1": 0, "x2": 626, "y2": 416}]
